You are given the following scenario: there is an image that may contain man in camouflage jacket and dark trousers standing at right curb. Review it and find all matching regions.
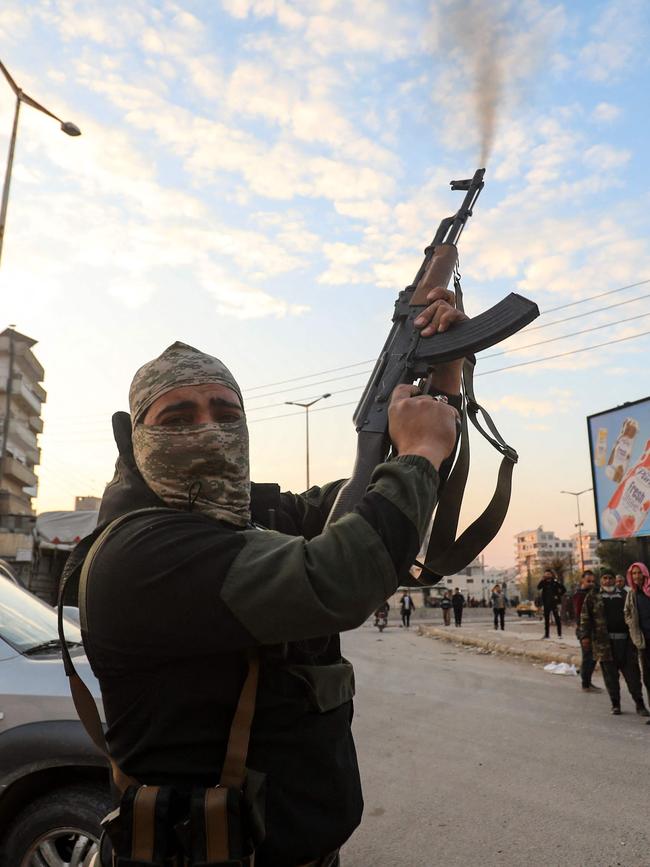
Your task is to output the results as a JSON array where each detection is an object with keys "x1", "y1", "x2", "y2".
[{"x1": 580, "y1": 572, "x2": 650, "y2": 716}]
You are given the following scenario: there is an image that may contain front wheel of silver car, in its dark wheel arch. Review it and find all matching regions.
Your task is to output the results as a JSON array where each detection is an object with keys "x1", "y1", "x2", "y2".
[{"x1": 2, "y1": 785, "x2": 112, "y2": 867}]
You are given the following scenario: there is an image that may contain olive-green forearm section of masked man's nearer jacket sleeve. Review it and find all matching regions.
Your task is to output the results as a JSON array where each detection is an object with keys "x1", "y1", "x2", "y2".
[{"x1": 221, "y1": 455, "x2": 438, "y2": 644}]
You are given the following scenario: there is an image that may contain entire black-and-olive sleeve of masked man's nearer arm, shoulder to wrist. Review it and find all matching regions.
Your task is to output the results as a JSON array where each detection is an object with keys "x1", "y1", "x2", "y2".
[{"x1": 87, "y1": 455, "x2": 438, "y2": 659}]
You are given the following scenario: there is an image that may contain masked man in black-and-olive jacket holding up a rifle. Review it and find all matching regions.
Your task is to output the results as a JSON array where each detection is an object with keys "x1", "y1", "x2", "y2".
[{"x1": 69, "y1": 293, "x2": 460, "y2": 867}]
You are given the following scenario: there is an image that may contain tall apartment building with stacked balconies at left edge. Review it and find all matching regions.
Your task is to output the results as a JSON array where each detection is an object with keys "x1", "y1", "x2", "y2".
[{"x1": 0, "y1": 328, "x2": 46, "y2": 575}]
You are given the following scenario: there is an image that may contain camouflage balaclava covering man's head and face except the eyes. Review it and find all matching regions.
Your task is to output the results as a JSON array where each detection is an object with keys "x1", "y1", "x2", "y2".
[{"x1": 129, "y1": 341, "x2": 250, "y2": 527}]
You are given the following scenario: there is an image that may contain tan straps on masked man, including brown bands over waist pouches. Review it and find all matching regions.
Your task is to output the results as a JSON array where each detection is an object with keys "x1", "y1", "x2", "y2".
[{"x1": 58, "y1": 507, "x2": 259, "y2": 863}]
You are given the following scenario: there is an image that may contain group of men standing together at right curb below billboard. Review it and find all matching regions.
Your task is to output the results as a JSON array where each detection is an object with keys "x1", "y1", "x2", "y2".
[{"x1": 574, "y1": 562, "x2": 650, "y2": 725}]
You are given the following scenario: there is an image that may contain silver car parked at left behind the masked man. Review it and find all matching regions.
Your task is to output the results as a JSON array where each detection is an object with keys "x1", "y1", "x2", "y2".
[{"x1": 0, "y1": 579, "x2": 112, "y2": 867}]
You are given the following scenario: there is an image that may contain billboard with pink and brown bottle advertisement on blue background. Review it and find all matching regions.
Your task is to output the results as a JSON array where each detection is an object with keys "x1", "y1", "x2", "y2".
[{"x1": 587, "y1": 397, "x2": 650, "y2": 540}]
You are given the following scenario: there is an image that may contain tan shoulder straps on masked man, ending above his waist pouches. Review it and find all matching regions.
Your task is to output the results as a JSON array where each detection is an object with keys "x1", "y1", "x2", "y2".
[{"x1": 58, "y1": 506, "x2": 259, "y2": 793}]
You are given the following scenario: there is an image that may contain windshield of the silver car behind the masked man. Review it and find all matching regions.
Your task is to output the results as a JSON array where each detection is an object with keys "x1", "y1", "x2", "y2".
[{"x1": 0, "y1": 580, "x2": 81, "y2": 653}]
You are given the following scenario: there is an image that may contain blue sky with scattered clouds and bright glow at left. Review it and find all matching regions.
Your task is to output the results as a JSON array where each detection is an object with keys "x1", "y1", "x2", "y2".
[{"x1": 0, "y1": 0, "x2": 650, "y2": 566}]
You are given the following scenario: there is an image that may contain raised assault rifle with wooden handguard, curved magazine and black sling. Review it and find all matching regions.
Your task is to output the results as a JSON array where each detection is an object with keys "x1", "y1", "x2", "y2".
[{"x1": 328, "y1": 169, "x2": 539, "y2": 584}]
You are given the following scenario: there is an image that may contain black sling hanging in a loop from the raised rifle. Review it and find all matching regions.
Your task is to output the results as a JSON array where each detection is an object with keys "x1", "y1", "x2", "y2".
[{"x1": 418, "y1": 273, "x2": 518, "y2": 583}]
